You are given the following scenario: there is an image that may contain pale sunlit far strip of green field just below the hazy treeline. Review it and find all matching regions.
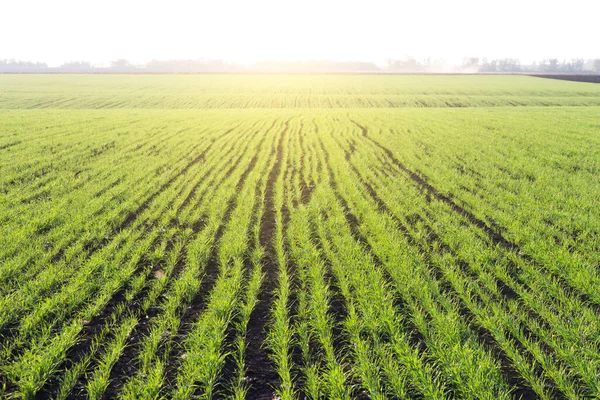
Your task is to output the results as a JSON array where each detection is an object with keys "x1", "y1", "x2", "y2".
[{"x1": 0, "y1": 75, "x2": 600, "y2": 109}]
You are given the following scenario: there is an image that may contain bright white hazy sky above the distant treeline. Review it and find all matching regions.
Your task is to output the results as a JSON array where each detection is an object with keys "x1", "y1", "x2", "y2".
[{"x1": 0, "y1": 0, "x2": 600, "y2": 65}]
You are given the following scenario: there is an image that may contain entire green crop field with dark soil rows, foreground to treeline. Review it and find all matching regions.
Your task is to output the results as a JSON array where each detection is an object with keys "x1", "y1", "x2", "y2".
[{"x1": 0, "y1": 75, "x2": 600, "y2": 400}]
